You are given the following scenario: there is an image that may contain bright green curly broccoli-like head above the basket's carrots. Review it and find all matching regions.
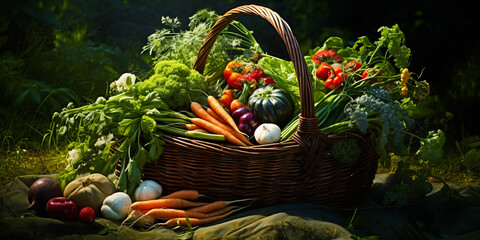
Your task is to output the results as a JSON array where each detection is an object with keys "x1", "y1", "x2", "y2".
[{"x1": 137, "y1": 60, "x2": 209, "y2": 110}]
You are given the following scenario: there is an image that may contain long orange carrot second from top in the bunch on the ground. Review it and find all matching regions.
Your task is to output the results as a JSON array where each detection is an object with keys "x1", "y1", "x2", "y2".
[{"x1": 130, "y1": 198, "x2": 205, "y2": 210}]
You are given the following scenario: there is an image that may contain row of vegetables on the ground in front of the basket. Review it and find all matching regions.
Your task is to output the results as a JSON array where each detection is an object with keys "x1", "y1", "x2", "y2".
[{"x1": 28, "y1": 173, "x2": 251, "y2": 228}]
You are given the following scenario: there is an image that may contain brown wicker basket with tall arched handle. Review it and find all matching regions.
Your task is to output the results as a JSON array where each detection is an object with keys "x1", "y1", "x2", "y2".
[{"x1": 131, "y1": 5, "x2": 378, "y2": 207}]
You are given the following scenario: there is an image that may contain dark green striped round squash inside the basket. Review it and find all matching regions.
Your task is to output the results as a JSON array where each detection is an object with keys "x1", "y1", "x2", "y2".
[{"x1": 248, "y1": 84, "x2": 295, "y2": 128}]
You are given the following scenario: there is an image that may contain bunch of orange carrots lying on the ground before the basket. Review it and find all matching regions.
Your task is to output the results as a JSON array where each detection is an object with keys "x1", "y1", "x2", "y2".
[{"x1": 125, "y1": 190, "x2": 249, "y2": 227}]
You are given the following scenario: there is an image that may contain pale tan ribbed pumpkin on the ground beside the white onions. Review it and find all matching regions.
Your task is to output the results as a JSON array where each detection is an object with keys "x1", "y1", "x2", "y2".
[{"x1": 63, "y1": 173, "x2": 117, "y2": 214}]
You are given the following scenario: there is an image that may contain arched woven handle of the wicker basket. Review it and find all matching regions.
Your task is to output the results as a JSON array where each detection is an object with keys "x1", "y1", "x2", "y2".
[{"x1": 194, "y1": 5, "x2": 319, "y2": 133}]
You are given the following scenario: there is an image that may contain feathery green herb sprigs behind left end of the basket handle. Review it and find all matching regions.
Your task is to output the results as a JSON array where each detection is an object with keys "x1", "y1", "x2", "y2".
[{"x1": 142, "y1": 9, "x2": 263, "y2": 84}]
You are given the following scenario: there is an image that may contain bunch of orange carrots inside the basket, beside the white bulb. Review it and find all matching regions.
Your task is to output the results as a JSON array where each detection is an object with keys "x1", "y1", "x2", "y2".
[{"x1": 187, "y1": 96, "x2": 253, "y2": 146}]
